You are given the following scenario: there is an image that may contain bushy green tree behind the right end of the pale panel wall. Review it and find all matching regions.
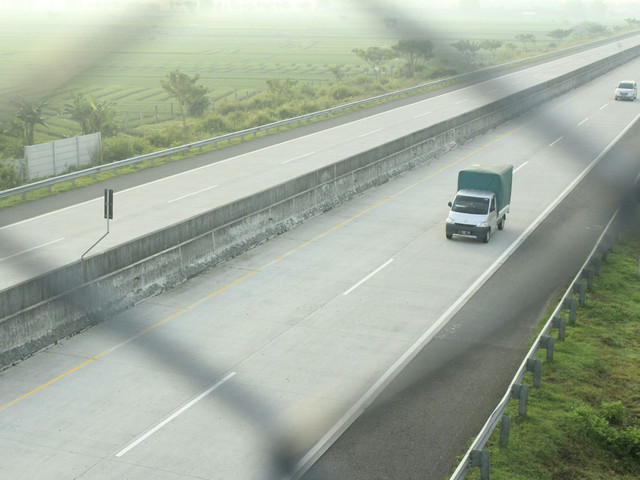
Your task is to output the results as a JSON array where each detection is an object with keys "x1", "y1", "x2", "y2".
[{"x1": 64, "y1": 93, "x2": 118, "y2": 137}]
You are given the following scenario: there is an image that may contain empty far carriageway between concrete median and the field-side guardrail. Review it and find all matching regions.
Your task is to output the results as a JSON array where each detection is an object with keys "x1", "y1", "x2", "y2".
[{"x1": 0, "y1": 37, "x2": 640, "y2": 290}]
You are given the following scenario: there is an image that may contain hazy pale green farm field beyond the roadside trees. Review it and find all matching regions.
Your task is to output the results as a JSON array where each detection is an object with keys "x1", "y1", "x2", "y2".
[{"x1": 0, "y1": 9, "x2": 624, "y2": 141}]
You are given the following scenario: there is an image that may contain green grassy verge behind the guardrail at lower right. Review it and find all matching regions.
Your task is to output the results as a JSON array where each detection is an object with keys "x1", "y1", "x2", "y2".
[{"x1": 466, "y1": 229, "x2": 640, "y2": 480}]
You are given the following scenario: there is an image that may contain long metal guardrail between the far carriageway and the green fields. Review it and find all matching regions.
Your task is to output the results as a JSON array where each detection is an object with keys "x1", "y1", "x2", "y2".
[{"x1": 0, "y1": 32, "x2": 638, "y2": 199}]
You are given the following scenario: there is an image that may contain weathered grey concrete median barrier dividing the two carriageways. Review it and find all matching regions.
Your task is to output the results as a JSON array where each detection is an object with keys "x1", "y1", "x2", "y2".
[{"x1": 0, "y1": 47, "x2": 640, "y2": 368}]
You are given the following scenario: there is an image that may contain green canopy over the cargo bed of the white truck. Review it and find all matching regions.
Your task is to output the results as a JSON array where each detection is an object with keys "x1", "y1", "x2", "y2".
[{"x1": 458, "y1": 165, "x2": 513, "y2": 211}]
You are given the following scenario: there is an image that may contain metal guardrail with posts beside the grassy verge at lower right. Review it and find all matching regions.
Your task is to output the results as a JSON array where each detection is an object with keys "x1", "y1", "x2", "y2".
[{"x1": 449, "y1": 211, "x2": 618, "y2": 480}]
